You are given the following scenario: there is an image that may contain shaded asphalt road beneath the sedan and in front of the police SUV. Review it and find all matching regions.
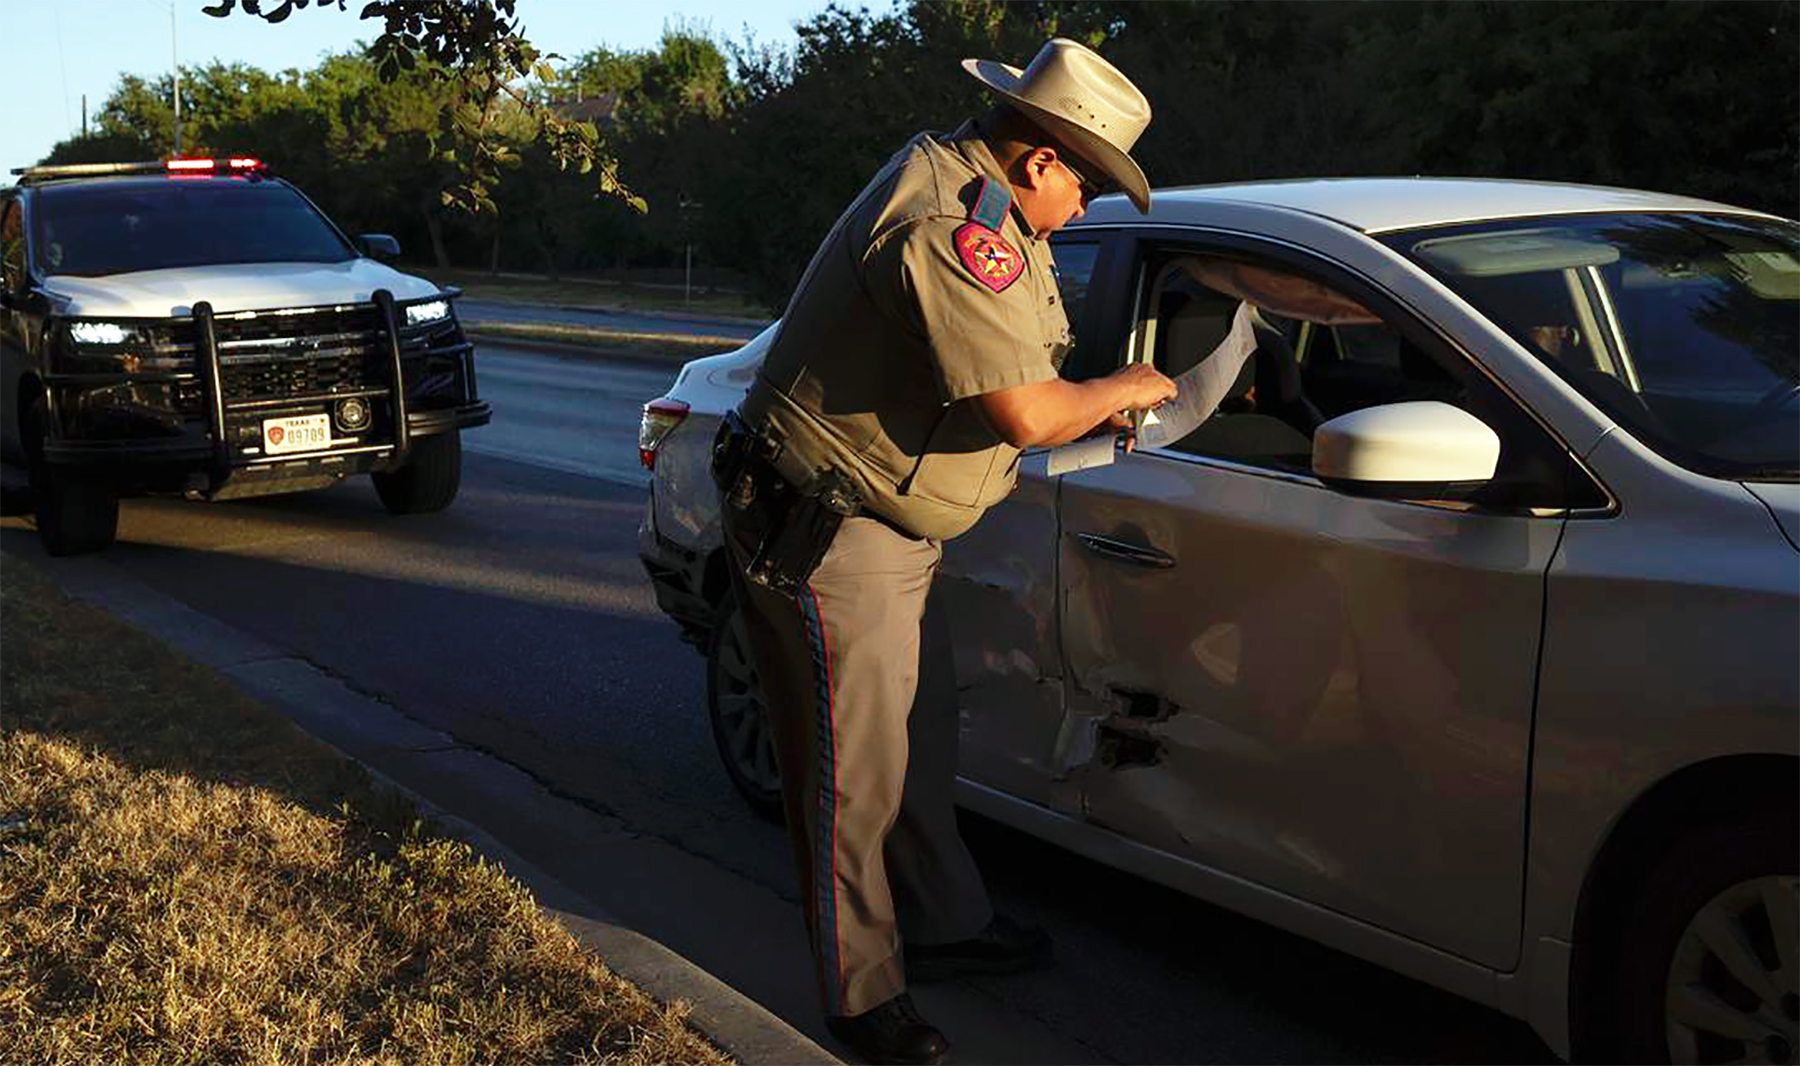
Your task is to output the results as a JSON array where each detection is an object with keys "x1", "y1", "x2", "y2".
[{"x1": 0, "y1": 333, "x2": 1552, "y2": 1062}]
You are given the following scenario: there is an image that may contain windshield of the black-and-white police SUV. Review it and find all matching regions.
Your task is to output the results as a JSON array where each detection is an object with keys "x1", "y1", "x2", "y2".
[{"x1": 31, "y1": 178, "x2": 356, "y2": 277}]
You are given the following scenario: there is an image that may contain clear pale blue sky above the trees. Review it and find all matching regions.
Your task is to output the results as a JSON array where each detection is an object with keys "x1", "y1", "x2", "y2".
[{"x1": 0, "y1": 0, "x2": 826, "y2": 174}]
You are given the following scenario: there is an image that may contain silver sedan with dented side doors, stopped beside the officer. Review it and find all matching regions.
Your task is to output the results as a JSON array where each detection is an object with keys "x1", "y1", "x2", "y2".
[{"x1": 641, "y1": 178, "x2": 1800, "y2": 1062}]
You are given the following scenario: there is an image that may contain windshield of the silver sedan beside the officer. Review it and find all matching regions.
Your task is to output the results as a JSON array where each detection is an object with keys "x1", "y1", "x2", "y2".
[{"x1": 1386, "y1": 214, "x2": 1800, "y2": 481}]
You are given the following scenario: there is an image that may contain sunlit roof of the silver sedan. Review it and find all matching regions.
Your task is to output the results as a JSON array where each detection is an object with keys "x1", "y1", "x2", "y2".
[{"x1": 1071, "y1": 178, "x2": 1773, "y2": 234}]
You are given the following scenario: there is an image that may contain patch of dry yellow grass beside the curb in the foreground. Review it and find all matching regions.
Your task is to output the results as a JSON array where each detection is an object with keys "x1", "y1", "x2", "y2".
[{"x1": 0, "y1": 558, "x2": 725, "y2": 1064}]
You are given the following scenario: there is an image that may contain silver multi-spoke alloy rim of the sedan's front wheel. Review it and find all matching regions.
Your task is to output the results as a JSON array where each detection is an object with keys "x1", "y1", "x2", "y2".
[{"x1": 1663, "y1": 877, "x2": 1800, "y2": 1064}]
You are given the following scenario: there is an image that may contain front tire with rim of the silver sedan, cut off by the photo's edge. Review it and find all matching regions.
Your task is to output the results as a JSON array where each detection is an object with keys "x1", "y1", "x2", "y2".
[{"x1": 1607, "y1": 810, "x2": 1800, "y2": 1062}]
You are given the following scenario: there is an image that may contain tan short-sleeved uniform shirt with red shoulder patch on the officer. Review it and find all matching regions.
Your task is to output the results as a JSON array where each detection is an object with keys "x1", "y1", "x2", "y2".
[{"x1": 743, "y1": 122, "x2": 1069, "y2": 540}]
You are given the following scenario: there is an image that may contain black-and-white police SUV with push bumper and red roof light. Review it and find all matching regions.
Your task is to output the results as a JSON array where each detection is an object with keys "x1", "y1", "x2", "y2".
[{"x1": 0, "y1": 158, "x2": 490, "y2": 555}]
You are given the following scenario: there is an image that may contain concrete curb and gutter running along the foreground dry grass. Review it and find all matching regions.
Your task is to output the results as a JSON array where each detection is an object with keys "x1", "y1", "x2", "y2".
[{"x1": 0, "y1": 540, "x2": 839, "y2": 1066}]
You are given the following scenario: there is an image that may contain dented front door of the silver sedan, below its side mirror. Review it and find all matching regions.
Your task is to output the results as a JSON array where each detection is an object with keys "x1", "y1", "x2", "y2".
[{"x1": 1049, "y1": 234, "x2": 1562, "y2": 969}]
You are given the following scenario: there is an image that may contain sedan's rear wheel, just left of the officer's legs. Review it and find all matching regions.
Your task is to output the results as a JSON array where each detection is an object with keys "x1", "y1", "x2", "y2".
[{"x1": 706, "y1": 594, "x2": 781, "y2": 821}]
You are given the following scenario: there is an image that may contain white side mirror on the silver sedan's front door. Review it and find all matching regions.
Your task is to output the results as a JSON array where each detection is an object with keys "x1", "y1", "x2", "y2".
[{"x1": 1312, "y1": 400, "x2": 1499, "y2": 499}]
